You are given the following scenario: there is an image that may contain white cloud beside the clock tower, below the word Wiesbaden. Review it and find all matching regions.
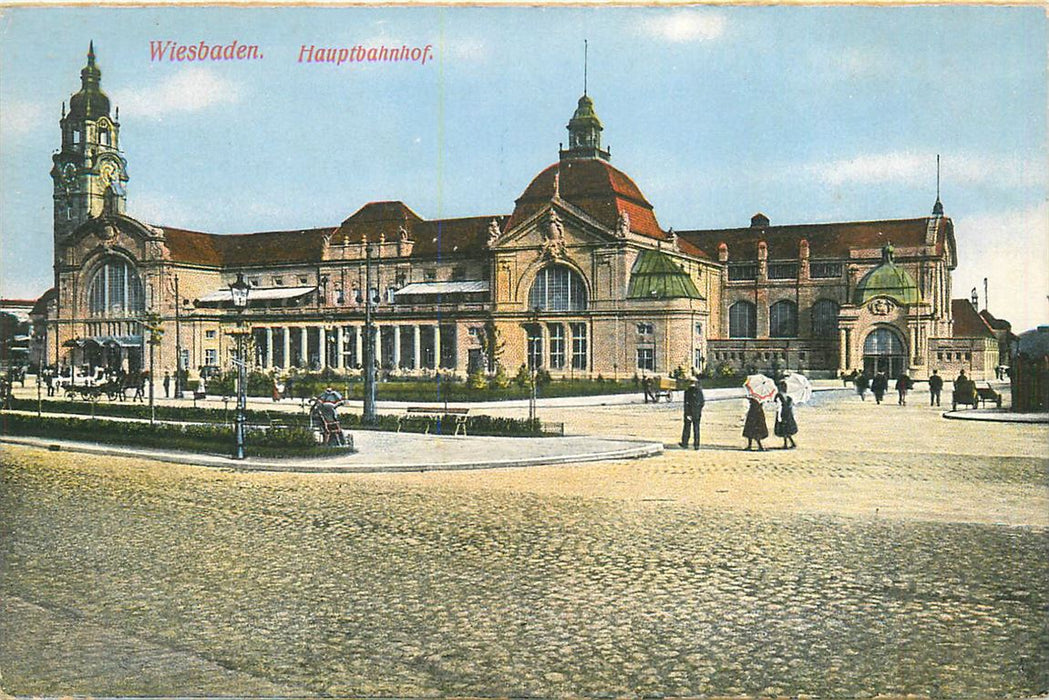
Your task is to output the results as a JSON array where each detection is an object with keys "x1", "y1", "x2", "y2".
[{"x1": 114, "y1": 66, "x2": 241, "y2": 119}]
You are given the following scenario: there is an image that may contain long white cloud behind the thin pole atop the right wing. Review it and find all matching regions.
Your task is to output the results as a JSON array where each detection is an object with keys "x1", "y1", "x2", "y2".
[{"x1": 804, "y1": 151, "x2": 1046, "y2": 187}]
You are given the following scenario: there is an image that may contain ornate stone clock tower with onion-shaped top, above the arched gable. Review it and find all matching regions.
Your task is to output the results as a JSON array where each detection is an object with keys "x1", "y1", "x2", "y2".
[{"x1": 51, "y1": 42, "x2": 128, "y2": 246}]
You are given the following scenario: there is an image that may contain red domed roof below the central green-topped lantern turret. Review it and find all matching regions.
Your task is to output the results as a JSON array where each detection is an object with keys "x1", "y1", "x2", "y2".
[{"x1": 508, "y1": 158, "x2": 665, "y2": 239}]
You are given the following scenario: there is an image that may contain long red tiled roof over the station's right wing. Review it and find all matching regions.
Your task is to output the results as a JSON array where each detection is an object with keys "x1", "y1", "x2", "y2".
[{"x1": 678, "y1": 217, "x2": 950, "y2": 261}]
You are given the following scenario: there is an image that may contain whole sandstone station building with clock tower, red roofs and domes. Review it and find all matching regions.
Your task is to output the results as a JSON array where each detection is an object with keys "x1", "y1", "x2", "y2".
[{"x1": 41, "y1": 50, "x2": 990, "y2": 388}]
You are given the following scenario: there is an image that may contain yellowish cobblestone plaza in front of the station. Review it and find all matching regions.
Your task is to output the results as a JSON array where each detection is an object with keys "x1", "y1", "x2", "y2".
[{"x1": 0, "y1": 391, "x2": 1049, "y2": 698}]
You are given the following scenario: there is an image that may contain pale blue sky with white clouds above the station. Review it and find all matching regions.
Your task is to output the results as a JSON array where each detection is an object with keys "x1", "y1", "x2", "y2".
[{"x1": 0, "y1": 5, "x2": 1049, "y2": 332}]
